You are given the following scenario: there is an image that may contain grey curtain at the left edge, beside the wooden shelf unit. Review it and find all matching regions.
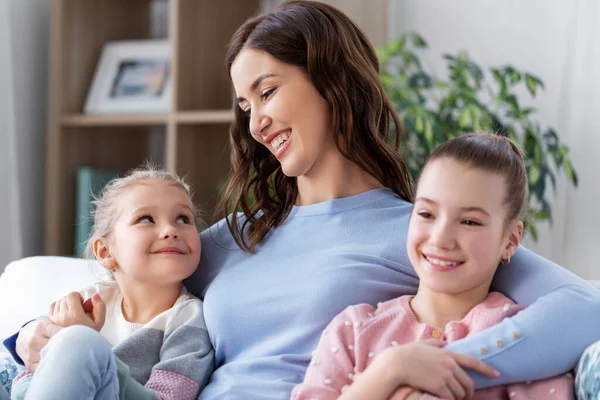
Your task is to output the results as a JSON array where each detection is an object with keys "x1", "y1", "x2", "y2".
[{"x1": 0, "y1": 0, "x2": 49, "y2": 272}]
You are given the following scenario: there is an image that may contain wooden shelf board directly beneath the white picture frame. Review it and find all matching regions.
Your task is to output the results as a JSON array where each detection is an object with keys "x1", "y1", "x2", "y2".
[{"x1": 61, "y1": 114, "x2": 168, "y2": 126}]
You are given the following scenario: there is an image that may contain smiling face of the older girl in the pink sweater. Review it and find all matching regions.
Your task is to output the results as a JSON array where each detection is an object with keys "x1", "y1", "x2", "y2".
[{"x1": 407, "y1": 158, "x2": 523, "y2": 298}]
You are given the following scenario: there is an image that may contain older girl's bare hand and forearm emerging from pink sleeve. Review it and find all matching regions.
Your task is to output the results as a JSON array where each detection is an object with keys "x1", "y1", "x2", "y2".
[{"x1": 378, "y1": 341, "x2": 499, "y2": 400}]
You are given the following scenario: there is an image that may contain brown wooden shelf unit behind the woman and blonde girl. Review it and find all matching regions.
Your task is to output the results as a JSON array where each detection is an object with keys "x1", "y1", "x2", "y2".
[{"x1": 44, "y1": 0, "x2": 260, "y2": 255}]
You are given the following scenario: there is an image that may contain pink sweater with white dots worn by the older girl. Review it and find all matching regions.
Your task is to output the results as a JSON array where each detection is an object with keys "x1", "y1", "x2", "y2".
[{"x1": 292, "y1": 292, "x2": 574, "y2": 400}]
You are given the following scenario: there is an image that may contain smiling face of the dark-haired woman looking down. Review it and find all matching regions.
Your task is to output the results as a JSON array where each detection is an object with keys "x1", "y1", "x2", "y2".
[{"x1": 231, "y1": 49, "x2": 339, "y2": 177}]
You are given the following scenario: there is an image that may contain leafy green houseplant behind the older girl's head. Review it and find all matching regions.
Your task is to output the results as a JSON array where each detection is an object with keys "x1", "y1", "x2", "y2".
[{"x1": 377, "y1": 33, "x2": 577, "y2": 239}]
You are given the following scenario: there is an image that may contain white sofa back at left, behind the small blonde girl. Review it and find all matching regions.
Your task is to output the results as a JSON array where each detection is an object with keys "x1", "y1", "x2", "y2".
[{"x1": 0, "y1": 256, "x2": 600, "y2": 348}]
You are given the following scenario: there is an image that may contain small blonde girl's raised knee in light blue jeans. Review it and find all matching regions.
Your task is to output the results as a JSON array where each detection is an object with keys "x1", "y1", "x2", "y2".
[{"x1": 26, "y1": 325, "x2": 119, "y2": 400}]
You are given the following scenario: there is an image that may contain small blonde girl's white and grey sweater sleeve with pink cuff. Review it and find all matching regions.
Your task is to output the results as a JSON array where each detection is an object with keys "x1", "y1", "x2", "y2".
[{"x1": 145, "y1": 298, "x2": 214, "y2": 400}]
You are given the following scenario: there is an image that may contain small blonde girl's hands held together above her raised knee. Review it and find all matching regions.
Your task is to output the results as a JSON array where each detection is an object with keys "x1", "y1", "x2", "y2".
[{"x1": 49, "y1": 292, "x2": 106, "y2": 331}]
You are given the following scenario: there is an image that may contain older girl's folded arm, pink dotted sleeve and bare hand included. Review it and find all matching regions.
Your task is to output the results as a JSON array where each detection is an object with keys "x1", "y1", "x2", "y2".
[{"x1": 292, "y1": 304, "x2": 494, "y2": 400}]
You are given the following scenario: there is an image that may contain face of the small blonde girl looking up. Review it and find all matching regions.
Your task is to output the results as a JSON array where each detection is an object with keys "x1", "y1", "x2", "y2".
[{"x1": 97, "y1": 181, "x2": 200, "y2": 285}]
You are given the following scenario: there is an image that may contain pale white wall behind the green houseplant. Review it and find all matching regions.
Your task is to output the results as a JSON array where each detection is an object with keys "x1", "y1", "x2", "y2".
[{"x1": 389, "y1": 0, "x2": 600, "y2": 279}]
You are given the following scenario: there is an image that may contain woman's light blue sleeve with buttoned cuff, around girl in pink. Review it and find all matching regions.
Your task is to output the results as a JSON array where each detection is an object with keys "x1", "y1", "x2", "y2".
[{"x1": 446, "y1": 247, "x2": 600, "y2": 389}]
